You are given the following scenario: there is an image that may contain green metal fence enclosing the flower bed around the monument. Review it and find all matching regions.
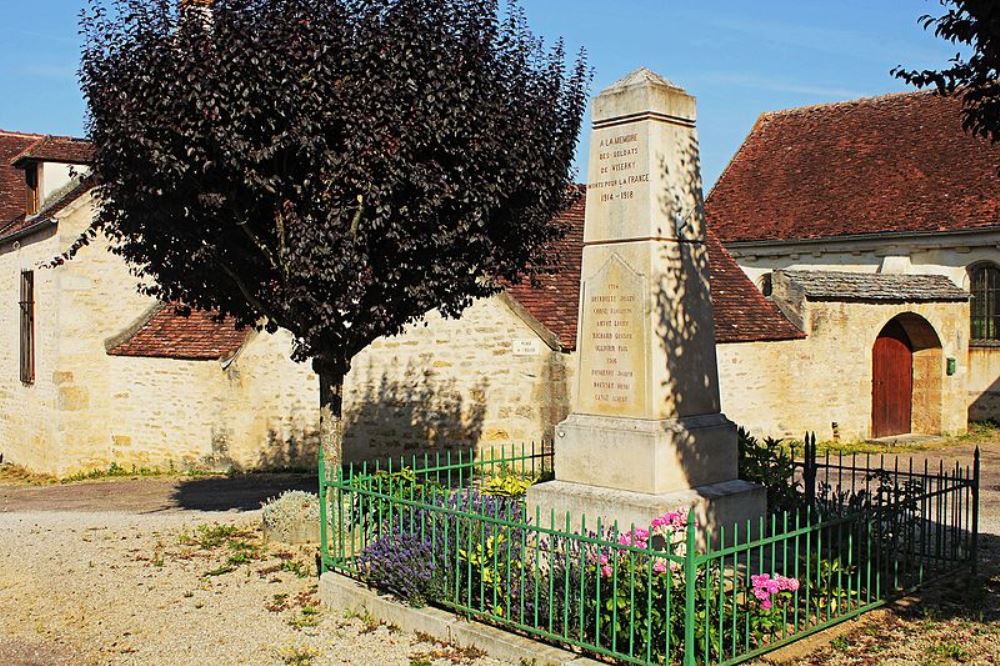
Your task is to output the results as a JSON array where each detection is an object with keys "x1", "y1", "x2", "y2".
[{"x1": 320, "y1": 438, "x2": 979, "y2": 664}]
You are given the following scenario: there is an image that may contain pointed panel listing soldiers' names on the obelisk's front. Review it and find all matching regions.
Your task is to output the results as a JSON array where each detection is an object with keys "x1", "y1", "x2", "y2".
[{"x1": 577, "y1": 254, "x2": 647, "y2": 417}]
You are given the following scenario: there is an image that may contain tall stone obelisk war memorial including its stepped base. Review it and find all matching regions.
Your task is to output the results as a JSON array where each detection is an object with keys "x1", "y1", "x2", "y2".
[{"x1": 528, "y1": 68, "x2": 766, "y2": 530}]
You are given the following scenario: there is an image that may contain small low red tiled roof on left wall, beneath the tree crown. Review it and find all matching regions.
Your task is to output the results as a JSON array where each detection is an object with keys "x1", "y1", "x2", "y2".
[{"x1": 108, "y1": 305, "x2": 247, "y2": 361}]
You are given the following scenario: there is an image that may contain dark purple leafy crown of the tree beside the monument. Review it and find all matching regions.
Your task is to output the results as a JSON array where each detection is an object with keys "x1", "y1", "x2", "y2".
[{"x1": 81, "y1": 0, "x2": 589, "y2": 371}]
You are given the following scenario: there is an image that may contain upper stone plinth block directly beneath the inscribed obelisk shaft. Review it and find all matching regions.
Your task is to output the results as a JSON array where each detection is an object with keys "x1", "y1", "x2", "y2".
[{"x1": 555, "y1": 413, "x2": 739, "y2": 495}]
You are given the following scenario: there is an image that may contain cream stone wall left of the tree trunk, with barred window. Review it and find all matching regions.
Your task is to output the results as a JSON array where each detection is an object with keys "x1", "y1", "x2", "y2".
[{"x1": 0, "y1": 196, "x2": 318, "y2": 475}]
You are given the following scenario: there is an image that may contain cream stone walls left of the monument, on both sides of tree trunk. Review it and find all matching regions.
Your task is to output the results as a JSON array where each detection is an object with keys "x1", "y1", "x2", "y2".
[{"x1": 0, "y1": 189, "x2": 569, "y2": 475}]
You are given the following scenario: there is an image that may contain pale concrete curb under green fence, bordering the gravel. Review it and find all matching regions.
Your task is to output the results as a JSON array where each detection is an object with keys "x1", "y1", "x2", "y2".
[{"x1": 319, "y1": 571, "x2": 602, "y2": 666}]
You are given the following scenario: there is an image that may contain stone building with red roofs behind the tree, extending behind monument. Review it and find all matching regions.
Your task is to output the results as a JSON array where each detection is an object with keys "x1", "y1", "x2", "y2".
[{"x1": 0, "y1": 127, "x2": 802, "y2": 474}]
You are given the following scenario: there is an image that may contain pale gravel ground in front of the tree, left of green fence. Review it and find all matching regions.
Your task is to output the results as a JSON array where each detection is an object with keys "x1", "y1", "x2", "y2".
[{"x1": 0, "y1": 511, "x2": 500, "y2": 665}]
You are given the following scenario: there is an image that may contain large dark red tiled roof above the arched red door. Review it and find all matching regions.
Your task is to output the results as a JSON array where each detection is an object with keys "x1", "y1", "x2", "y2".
[{"x1": 706, "y1": 92, "x2": 1000, "y2": 244}]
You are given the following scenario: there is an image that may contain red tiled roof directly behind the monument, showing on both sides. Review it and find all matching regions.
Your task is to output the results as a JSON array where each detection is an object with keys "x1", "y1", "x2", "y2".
[{"x1": 507, "y1": 197, "x2": 805, "y2": 349}]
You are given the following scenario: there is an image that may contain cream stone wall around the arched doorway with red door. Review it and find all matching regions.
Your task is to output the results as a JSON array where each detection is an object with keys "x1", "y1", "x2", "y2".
[{"x1": 718, "y1": 302, "x2": 968, "y2": 441}]
